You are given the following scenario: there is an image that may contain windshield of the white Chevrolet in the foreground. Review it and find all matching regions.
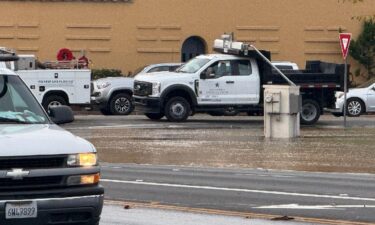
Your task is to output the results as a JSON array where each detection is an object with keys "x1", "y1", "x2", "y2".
[{"x1": 0, "y1": 75, "x2": 49, "y2": 124}]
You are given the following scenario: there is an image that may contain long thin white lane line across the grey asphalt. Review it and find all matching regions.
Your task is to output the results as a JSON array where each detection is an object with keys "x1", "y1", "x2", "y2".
[{"x1": 100, "y1": 179, "x2": 375, "y2": 202}]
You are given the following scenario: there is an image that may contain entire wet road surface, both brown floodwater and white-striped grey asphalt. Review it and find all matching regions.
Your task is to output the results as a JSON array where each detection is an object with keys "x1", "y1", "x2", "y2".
[{"x1": 64, "y1": 115, "x2": 375, "y2": 224}]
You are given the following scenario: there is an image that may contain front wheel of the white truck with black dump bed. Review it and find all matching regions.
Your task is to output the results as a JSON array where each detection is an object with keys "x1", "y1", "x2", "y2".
[{"x1": 164, "y1": 96, "x2": 191, "y2": 122}]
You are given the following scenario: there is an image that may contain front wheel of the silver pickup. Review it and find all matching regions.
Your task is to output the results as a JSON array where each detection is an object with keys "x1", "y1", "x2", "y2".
[{"x1": 109, "y1": 93, "x2": 134, "y2": 116}]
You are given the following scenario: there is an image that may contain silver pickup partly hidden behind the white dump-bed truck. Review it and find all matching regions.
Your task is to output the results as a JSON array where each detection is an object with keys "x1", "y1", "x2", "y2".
[{"x1": 91, "y1": 63, "x2": 182, "y2": 115}]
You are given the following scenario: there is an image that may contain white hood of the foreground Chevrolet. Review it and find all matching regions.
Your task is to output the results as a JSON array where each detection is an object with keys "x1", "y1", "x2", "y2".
[{"x1": 0, "y1": 124, "x2": 95, "y2": 157}]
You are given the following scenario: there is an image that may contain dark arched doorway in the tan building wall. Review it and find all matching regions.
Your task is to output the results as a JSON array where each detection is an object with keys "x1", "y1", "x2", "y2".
[{"x1": 181, "y1": 36, "x2": 206, "y2": 62}]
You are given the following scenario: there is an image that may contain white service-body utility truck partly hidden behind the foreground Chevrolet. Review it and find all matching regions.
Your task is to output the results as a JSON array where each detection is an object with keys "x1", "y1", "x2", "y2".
[{"x1": 0, "y1": 48, "x2": 91, "y2": 110}]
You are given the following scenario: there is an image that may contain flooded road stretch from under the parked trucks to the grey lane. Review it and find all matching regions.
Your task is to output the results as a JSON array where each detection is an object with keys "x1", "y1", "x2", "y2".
[{"x1": 64, "y1": 115, "x2": 375, "y2": 173}]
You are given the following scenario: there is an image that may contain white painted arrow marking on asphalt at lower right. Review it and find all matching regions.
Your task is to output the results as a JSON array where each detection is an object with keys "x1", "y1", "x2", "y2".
[{"x1": 253, "y1": 204, "x2": 375, "y2": 209}]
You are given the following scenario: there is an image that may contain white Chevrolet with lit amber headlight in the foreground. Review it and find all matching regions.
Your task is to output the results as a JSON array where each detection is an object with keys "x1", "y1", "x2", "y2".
[{"x1": 0, "y1": 66, "x2": 104, "y2": 225}]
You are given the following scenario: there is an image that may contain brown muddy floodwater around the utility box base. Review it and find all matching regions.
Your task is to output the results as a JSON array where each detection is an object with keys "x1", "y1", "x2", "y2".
[{"x1": 73, "y1": 128, "x2": 375, "y2": 173}]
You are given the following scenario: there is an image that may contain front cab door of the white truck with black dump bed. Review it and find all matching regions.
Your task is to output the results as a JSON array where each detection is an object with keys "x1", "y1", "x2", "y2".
[{"x1": 197, "y1": 60, "x2": 234, "y2": 105}]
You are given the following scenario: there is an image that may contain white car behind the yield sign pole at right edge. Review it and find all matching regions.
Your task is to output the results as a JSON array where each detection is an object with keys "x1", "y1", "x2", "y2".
[{"x1": 332, "y1": 79, "x2": 375, "y2": 117}]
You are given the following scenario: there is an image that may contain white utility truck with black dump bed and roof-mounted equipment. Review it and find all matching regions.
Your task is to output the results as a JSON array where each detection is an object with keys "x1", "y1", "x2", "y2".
[{"x1": 133, "y1": 34, "x2": 345, "y2": 124}]
